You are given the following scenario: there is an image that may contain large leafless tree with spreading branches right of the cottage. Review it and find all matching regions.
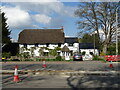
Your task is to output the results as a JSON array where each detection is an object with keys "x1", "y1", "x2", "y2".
[{"x1": 75, "y1": 2, "x2": 119, "y2": 53}]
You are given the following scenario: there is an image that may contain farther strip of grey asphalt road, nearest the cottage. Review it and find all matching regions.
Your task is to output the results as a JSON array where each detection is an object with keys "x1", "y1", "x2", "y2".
[{"x1": 2, "y1": 61, "x2": 120, "y2": 71}]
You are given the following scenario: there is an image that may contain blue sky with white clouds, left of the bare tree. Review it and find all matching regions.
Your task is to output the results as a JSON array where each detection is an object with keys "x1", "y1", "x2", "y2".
[{"x1": 1, "y1": 2, "x2": 79, "y2": 40}]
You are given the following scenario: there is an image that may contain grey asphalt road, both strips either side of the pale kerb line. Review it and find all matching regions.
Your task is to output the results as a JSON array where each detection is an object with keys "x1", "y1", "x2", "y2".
[{"x1": 2, "y1": 61, "x2": 120, "y2": 90}]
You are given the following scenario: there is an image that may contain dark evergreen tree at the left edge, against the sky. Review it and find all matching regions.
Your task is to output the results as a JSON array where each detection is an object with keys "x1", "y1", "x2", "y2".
[{"x1": 0, "y1": 12, "x2": 11, "y2": 45}]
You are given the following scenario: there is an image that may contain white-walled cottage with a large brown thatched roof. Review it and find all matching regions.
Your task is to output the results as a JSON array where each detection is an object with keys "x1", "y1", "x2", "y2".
[{"x1": 18, "y1": 27, "x2": 79, "y2": 56}]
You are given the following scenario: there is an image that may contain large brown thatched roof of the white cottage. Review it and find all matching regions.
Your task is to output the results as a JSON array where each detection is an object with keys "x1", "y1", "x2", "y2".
[{"x1": 18, "y1": 29, "x2": 64, "y2": 44}]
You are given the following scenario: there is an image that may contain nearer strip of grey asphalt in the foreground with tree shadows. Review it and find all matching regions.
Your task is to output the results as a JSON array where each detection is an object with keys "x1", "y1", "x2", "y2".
[{"x1": 2, "y1": 75, "x2": 120, "y2": 90}]
